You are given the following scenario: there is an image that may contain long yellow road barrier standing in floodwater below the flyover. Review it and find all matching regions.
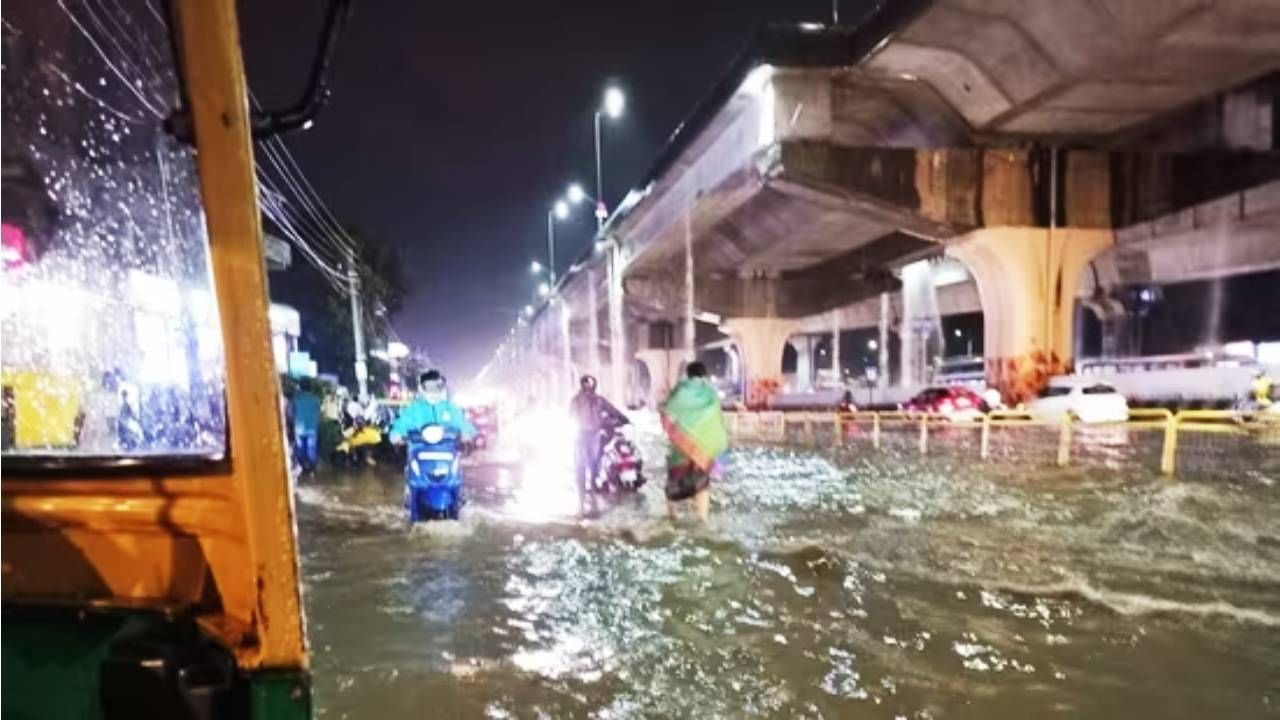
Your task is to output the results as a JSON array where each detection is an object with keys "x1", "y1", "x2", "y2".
[{"x1": 726, "y1": 409, "x2": 1280, "y2": 477}]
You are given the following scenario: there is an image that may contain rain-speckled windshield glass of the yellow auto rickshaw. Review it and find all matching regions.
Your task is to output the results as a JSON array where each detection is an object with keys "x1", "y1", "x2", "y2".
[{"x1": 0, "y1": 0, "x2": 227, "y2": 461}]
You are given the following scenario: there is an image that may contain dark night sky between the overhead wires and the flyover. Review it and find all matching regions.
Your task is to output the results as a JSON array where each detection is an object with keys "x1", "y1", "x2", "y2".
[{"x1": 241, "y1": 0, "x2": 849, "y2": 375}]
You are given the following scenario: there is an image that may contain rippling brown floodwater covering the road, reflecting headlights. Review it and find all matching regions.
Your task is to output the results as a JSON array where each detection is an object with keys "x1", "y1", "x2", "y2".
[{"x1": 298, "y1": 417, "x2": 1280, "y2": 719}]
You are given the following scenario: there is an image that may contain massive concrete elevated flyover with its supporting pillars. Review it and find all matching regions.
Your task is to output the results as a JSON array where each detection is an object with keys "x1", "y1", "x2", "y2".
[{"x1": 501, "y1": 0, "x2": 1280, "y2": 397}]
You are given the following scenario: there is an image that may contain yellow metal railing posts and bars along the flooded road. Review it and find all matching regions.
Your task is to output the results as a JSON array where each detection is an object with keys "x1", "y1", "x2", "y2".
[{"x1": 726, "y1": 407, "x2": 1280, "y2": 477}]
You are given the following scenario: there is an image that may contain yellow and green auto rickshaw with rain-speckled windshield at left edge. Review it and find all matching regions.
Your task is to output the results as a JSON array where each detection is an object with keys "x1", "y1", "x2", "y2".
[{"x1": 0, "y1": 0, "x2": 348, "y2": 720}]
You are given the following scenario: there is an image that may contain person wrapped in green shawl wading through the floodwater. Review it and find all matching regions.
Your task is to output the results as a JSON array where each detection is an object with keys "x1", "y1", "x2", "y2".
[{"x1": 662, "y1": 363, "x2": 728, "y2": 521}]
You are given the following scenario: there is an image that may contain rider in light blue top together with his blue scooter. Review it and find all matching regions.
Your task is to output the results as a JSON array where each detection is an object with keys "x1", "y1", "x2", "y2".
[{"x1": 390, "y1": 370, "x2": 476, "y2": 523}]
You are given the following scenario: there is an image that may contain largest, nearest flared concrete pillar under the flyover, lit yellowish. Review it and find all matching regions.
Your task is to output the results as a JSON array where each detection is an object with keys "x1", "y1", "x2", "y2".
[{"x1": 947, "y1": 227, "x2": 1114, "y2": 402}]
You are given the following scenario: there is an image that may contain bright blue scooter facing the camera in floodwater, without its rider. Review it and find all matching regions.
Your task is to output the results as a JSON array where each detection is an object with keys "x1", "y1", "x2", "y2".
[{"x1": 404, "y1": 425, "x2": 462, "y2": 523}]
